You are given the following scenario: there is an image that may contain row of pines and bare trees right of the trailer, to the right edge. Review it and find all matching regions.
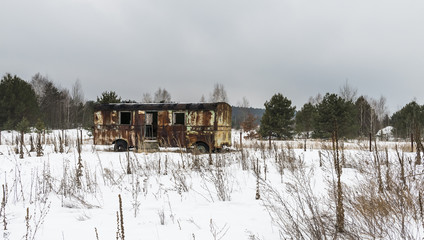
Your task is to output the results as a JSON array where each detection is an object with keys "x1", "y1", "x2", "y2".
[{"x1": 259, "y1": 83, "x2": 424, "y2": 139}]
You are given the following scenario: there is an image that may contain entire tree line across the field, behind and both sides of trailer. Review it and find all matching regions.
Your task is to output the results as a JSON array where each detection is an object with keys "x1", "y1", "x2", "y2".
[{"x1": 0, "y1": 73, "x2": 424, "y2": 139}]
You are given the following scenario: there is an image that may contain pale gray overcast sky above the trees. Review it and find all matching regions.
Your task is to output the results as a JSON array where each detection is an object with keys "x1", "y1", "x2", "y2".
[{"x1": 0, "y1": 0, "x2": 424, "y2": 113}]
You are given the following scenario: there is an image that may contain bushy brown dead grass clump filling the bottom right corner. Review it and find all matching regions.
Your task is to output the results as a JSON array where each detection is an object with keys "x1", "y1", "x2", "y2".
[{"x1": 345, "y1": 146, "x2": 424, "y2": 239}]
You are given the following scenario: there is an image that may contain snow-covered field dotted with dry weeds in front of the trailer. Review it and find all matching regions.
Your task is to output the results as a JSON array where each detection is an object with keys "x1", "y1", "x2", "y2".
[{"x1": 0, "y1": 130, "x2": 424, "y2": 240}]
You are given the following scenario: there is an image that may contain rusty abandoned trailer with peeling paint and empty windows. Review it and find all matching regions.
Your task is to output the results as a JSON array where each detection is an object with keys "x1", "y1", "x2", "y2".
[{"x1": 93, "y1": 102, "x2": 232, "y2": 152}]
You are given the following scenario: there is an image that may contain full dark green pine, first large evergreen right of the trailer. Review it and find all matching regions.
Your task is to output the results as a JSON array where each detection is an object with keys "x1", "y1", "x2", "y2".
[{"x1": 259, "y1": 93, "x2": 296, "y2": 139}]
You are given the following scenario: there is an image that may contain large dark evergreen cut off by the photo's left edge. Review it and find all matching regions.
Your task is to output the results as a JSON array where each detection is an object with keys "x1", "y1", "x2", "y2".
[{"x1": 0, "y1": 73, "x2": 39, "y2": 129}]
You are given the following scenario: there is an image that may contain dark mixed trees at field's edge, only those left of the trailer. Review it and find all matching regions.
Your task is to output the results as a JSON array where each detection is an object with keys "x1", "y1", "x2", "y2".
[{"x1": 0, "y1": 73, "x2": 94, "y2": 130}]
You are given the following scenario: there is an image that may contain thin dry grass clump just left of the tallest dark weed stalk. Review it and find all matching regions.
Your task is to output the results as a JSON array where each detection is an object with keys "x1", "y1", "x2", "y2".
[{"x1": 261, "y1": 158, "x2": 335, "y2": 239}]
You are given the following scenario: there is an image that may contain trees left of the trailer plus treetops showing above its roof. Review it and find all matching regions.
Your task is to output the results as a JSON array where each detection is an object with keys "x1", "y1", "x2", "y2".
[{"x1": 0, "y1": 73, "x2": 232, "y2": 130}]
